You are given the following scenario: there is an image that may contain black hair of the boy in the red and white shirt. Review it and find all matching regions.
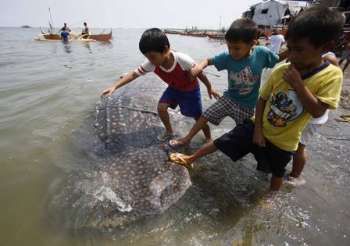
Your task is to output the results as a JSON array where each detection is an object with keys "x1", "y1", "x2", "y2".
[{"x1": 139, "y1": 28, "x2": 170, "y2": 54}]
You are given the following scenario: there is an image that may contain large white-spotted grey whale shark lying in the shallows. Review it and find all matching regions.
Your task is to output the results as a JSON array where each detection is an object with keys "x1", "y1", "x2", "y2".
[{"x1": 49, "y1": 85, "x2": 191, "y2": 229}]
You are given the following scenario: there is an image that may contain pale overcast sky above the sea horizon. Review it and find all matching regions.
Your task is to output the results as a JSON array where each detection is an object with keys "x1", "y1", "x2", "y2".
[{"x1": 0, "y1": 0, "x2": 259, "y2": 28}]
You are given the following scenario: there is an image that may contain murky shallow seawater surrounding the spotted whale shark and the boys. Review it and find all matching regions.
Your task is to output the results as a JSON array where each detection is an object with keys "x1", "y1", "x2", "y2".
[{"x1": 0, "y1": 28, "x2": 350, "y2": 246}]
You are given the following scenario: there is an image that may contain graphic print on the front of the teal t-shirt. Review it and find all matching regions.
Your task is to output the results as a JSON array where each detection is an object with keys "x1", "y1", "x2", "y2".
[{"x1": 229, "y1": 66, "x2": 260, "y2": 96}]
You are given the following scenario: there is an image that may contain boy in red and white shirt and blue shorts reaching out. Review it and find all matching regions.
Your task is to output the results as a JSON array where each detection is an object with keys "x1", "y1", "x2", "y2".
[{"x1": 102, "y1": 28, "x2": 218, "y2": 141}]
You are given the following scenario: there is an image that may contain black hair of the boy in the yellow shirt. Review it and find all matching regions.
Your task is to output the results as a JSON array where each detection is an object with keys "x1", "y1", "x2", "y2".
[{"x1": 286, "y1": 6, "x2": 345, "y2": 47}]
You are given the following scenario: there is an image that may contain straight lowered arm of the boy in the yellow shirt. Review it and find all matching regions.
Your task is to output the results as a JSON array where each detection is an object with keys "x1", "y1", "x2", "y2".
[{"x1": 253, "y1": 97, "x2": 266, "y2": 147}]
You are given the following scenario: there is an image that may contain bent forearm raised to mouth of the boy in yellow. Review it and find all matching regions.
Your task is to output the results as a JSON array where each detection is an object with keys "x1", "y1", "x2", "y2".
[{"x1": 283, "y1": 65, "x2": 329, "y2": 118}]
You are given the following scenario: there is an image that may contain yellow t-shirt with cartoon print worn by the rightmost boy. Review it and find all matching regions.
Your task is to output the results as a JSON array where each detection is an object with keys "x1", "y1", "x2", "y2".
[{"x1": 260, "y1": 64, "x2": 343, "y2": 151}]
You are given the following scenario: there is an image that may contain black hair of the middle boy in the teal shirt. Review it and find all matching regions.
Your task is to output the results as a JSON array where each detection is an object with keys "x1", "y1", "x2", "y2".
[{"x1": 225, "y1": 18, "x2": 258, "y2": 43}]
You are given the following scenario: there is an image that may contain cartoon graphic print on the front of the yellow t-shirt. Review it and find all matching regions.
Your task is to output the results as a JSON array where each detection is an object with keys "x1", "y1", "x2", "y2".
[{"x1": 267, "y1": 90, "x2": 304, "y2": 127}]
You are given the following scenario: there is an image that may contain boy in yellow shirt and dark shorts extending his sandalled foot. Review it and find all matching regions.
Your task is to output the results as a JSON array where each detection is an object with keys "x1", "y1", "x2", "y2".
[{"x1": 170, "y1": 7, "x2": 344, "y2": 190}]
